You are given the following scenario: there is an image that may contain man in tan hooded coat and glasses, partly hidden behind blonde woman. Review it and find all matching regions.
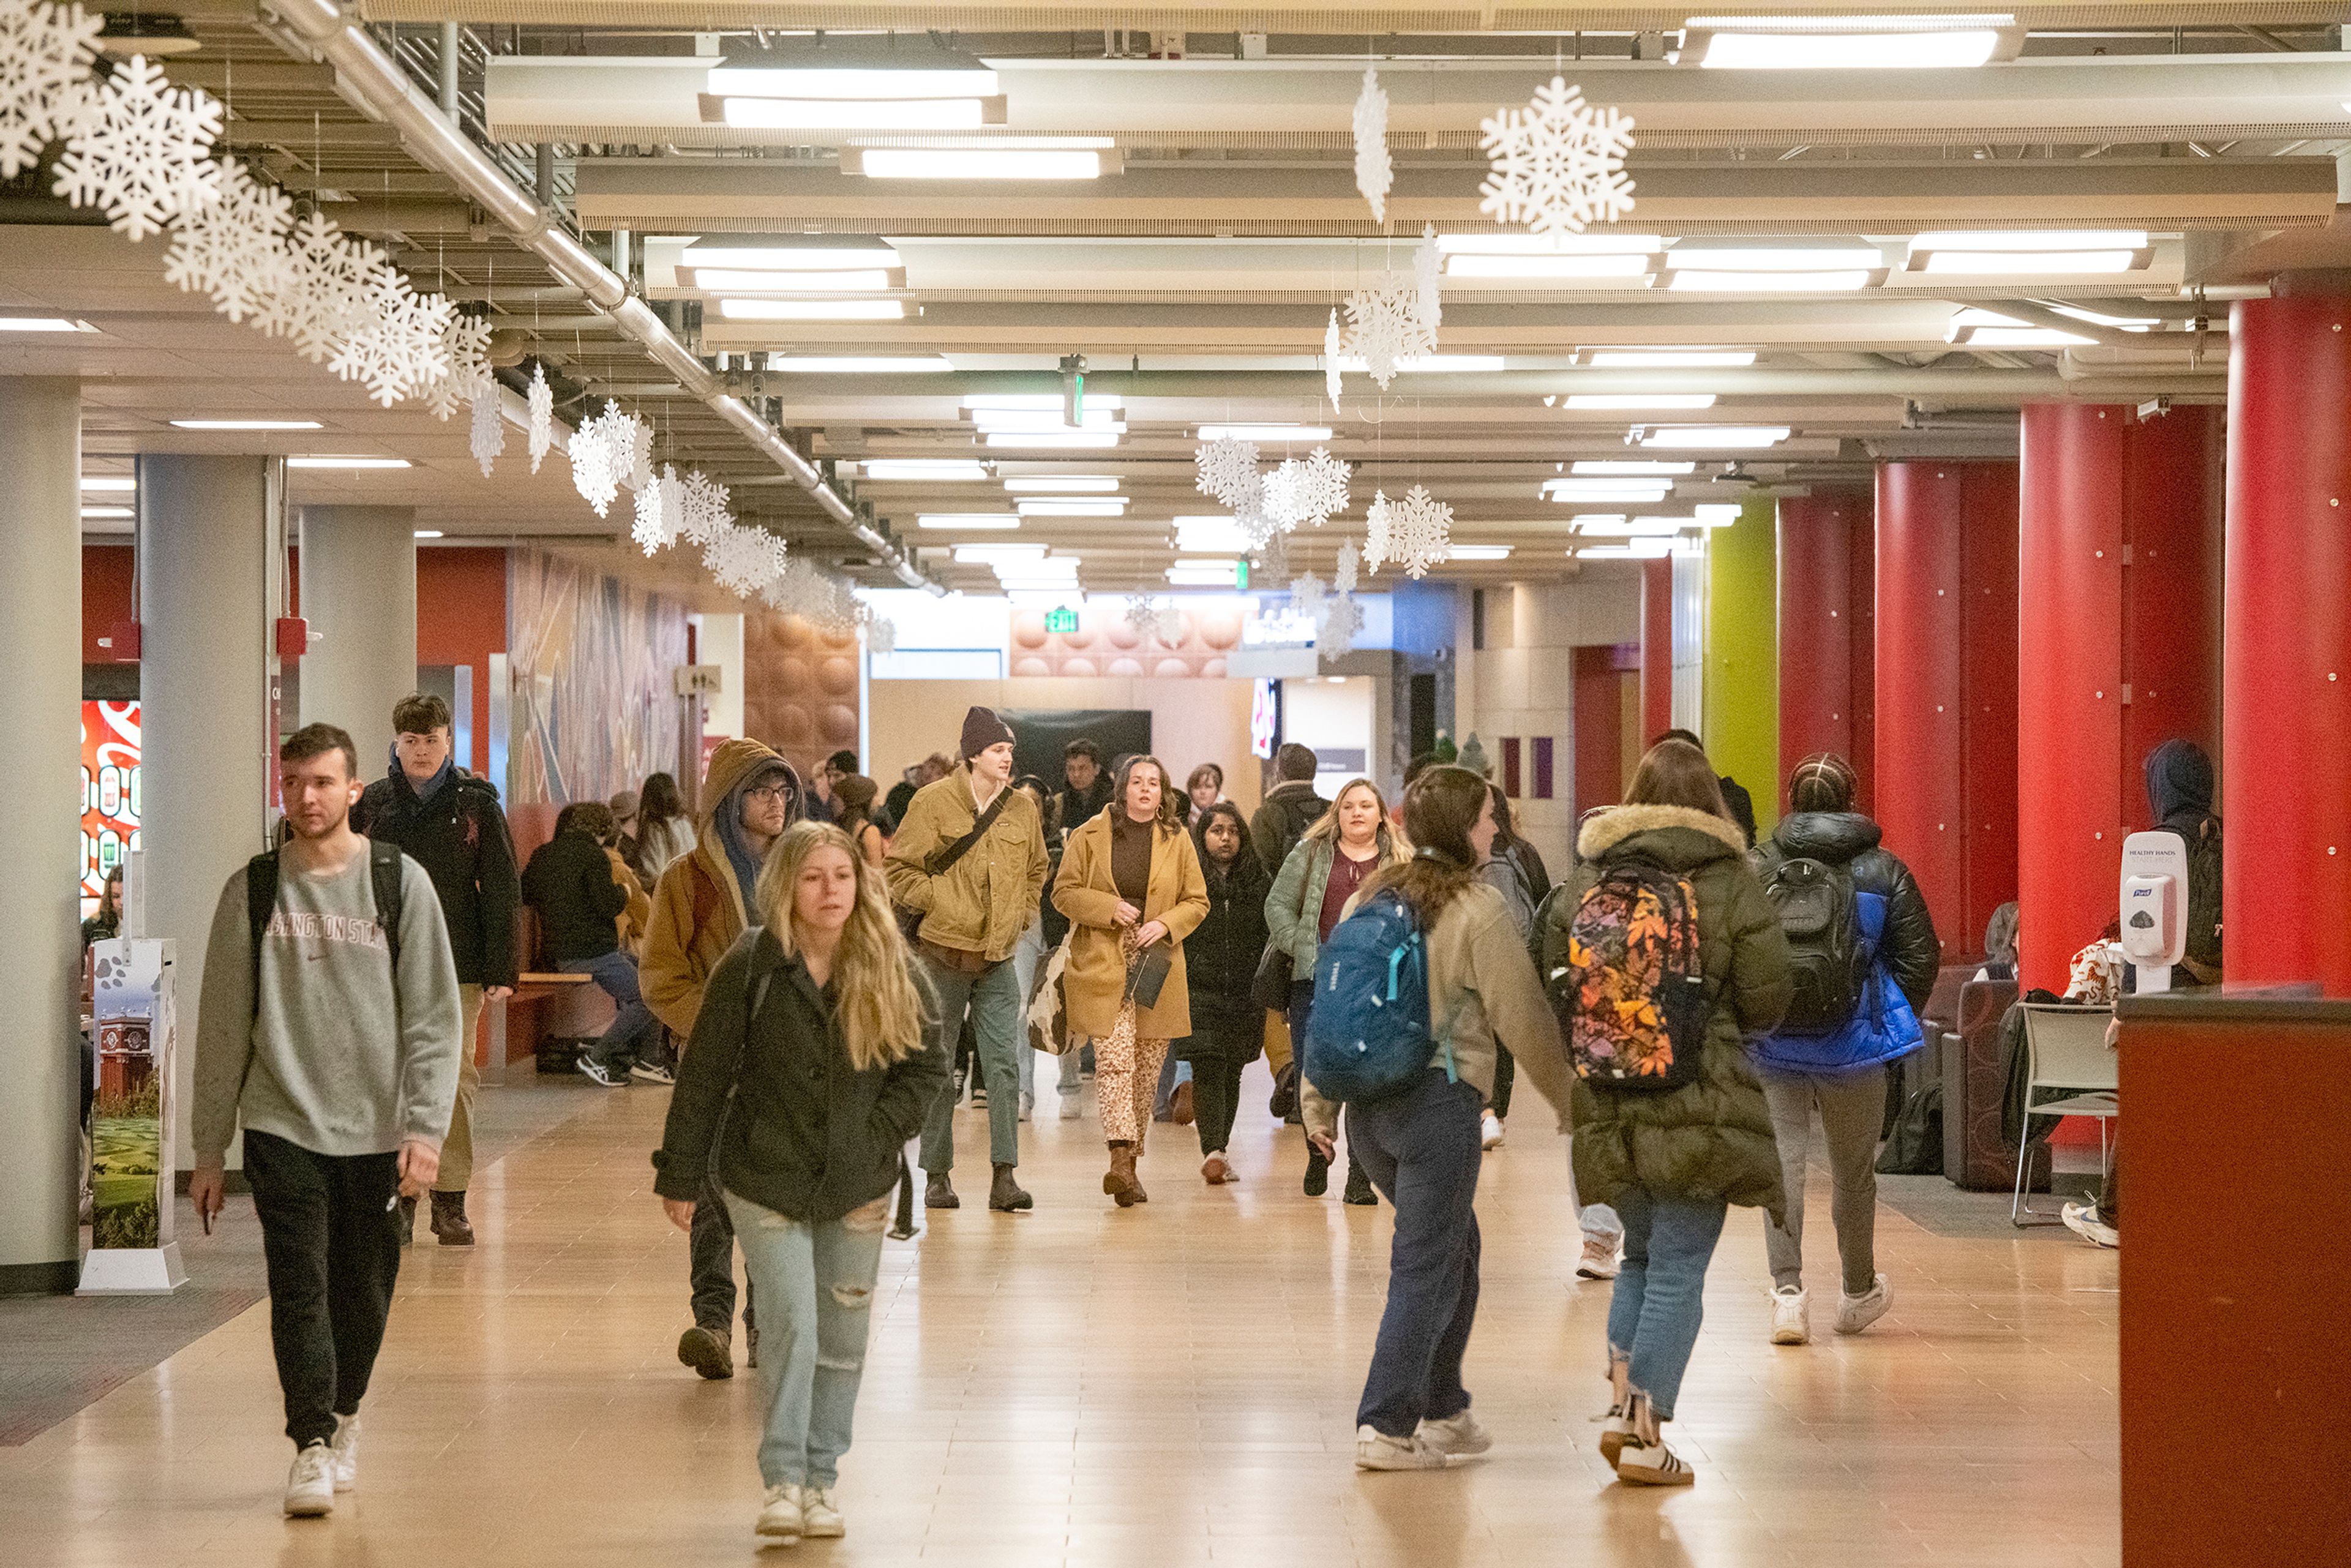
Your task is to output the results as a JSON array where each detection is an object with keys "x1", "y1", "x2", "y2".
[{"x1": 637, "y1": 740, "x2": 801, "y2": 1378}]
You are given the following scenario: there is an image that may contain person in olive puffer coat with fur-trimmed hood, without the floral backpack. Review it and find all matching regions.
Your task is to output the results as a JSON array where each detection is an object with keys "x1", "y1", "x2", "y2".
[{"x1": 1535, "y1": 740, "x2": 1789, "y2": 1486}]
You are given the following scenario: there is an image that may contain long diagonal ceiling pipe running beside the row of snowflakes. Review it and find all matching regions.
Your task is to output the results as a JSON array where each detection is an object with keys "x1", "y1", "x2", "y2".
[{"x1": 246, "y1": 0, "x2": 926, "y2": 595}]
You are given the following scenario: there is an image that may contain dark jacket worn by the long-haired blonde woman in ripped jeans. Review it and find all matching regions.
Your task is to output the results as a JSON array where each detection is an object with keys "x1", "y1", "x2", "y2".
[{"x1": 654, "y1": 926, "x2": 948, "y2": 1223}]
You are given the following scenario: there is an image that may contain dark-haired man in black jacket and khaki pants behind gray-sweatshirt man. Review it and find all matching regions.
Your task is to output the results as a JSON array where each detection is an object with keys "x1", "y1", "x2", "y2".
[{"x1": 350, "y1": 691, "x2": 522, "y2": 1246}]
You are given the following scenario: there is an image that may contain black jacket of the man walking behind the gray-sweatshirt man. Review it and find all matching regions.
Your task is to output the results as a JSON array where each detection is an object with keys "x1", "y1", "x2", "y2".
[{"x1": 350, "y1": 762, "x2": 522, "y2": 985}]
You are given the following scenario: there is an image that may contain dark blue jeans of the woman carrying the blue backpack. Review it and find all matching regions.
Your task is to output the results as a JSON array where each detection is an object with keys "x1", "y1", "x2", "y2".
[{"x1": 1347, "y1": 1070, "x2": 1483, "y2": 1436}]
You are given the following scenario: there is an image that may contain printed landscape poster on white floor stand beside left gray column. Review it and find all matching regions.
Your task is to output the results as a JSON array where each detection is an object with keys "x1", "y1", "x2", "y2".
[{"x1": 89, "y1": 938, "x2": 174, "y2": 1248}]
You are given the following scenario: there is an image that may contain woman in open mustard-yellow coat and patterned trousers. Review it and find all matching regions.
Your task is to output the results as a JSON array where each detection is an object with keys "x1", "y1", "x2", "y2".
[{"x1": 1053, "y1": 757, "x2": 1209, "y2": 1209}]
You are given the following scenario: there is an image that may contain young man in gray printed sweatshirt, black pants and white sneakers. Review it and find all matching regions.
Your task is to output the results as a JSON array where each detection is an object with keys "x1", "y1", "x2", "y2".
[{"x1": 188, "y1": 724, "x2": 459, "y2": 1517}]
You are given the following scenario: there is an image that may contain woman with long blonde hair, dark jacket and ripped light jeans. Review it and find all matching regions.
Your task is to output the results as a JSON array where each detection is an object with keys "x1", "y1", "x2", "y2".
[{"x1": 654, "y1": 823, "x2": 948, "y2": 1542}]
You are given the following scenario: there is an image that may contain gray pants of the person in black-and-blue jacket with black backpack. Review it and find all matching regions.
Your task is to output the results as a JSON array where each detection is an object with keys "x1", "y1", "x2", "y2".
[{"x1": 1756, "y1": 1067, "x2": 1886, "y2": 1296}]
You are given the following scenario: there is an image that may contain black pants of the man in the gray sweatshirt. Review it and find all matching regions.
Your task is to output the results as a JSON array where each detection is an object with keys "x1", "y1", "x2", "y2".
[{"x1": 244, "y1": 1128, "x2": 400, "y2": 1448}]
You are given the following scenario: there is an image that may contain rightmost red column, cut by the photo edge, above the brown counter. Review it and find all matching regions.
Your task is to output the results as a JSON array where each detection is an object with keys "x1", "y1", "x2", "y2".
[{"x1": 2219, "y1": 293, "x2": 2351, "y2": 997}]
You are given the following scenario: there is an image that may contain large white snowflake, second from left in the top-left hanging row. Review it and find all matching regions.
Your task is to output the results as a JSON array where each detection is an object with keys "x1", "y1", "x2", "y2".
[{"x1": 51, "y1": 54, "x2": 221, "y2": 240}]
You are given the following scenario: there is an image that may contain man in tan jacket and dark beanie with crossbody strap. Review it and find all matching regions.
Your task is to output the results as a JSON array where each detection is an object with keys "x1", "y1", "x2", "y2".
[{"x1": 882, "y1": 708, "x2": 1044, "y2": 1213}]
